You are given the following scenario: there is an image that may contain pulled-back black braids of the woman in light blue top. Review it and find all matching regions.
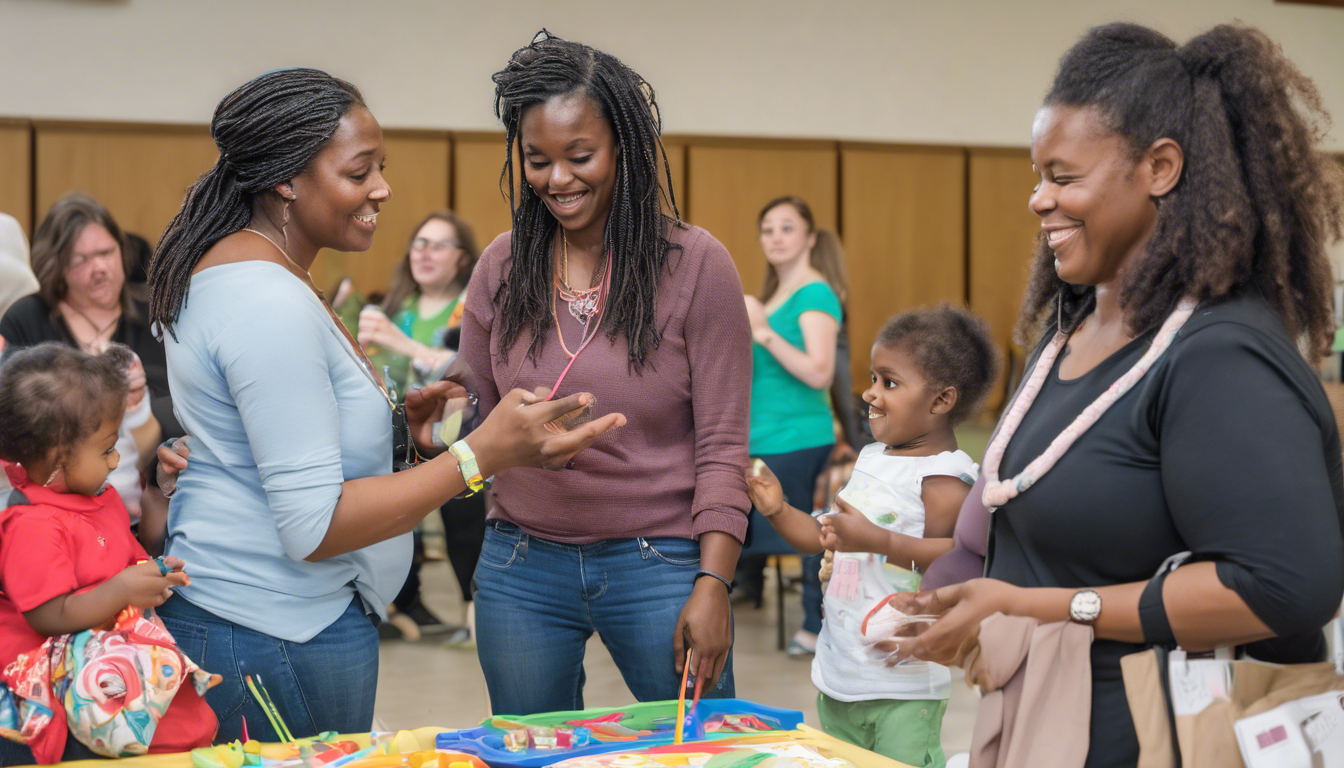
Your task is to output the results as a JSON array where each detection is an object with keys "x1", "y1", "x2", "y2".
[{"x1": 149, "y1": 69, "x2": 364, "y2": 339}]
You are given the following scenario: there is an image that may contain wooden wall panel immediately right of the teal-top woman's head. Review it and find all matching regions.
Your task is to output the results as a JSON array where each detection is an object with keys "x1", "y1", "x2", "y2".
[{"x1": 840, "y1": 144, "x2": 966, "y2": 390}]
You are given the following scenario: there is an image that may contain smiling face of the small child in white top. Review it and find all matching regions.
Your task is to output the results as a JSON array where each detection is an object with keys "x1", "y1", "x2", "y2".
[{"x1": 863, "y1": 343, "x2": 956, "y2": 445}]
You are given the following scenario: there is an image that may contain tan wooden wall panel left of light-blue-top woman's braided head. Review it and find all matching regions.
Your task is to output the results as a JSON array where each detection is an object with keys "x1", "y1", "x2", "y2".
[{"x1": 34, "y1": 121, "x2": 219, "y2": 243}]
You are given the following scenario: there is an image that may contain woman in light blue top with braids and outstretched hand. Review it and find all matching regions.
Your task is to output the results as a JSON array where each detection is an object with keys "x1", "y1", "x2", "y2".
[{"x1": 149, "y1": 70, "x2": 622, "y2": 741}]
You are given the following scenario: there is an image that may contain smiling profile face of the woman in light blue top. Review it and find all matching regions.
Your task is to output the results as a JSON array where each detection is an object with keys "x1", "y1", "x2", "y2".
[{"x1": 281, "y1": 106, "x2": 392, "y2": 252}]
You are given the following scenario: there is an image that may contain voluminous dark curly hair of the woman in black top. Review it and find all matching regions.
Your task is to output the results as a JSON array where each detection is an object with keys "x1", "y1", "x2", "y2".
[{"x1": 1017, "y1": 24, "x2": 1344, "y2": 358}]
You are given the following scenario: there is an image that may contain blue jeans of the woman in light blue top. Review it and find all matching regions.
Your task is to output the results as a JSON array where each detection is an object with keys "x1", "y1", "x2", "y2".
[{"x1": 159, "y1": 596, "x2": 378, "y2": 744}]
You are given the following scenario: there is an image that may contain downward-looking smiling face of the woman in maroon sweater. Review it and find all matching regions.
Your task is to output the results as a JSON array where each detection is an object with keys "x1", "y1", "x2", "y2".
[{"x1": 519, "y1": 94, "x2": 620, "y2": 233}]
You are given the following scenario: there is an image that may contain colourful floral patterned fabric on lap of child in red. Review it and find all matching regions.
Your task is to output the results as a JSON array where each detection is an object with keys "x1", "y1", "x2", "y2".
[{"x1": 0, "y1": 608, "x2": 220, "y2": 764}]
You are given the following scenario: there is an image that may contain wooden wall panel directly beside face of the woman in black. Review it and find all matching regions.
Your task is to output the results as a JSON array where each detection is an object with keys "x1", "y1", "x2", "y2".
[{"x1": 968, "y1": 149, "x2": 1040, "y2": 408}]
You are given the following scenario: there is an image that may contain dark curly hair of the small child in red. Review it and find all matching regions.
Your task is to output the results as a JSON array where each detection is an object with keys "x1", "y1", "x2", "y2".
[{"x1": 0, "y1": 342, "x2": 134, "y2": 464}]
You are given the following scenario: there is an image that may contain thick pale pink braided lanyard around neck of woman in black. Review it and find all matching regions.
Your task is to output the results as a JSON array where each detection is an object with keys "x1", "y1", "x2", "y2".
[{"x1": 984, "y1": 297, "x2": 1196, "y2": 512}]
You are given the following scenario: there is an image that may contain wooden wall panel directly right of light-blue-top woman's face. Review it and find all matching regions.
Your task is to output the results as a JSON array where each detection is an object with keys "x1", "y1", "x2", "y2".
[{"x1": 312, "y1": 129, "x2": 452, "y2": 295}]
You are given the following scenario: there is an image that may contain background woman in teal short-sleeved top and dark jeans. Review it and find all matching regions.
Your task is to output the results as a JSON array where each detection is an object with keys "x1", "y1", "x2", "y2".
[{"x1": 739, "y1": 198, "x2": 844, "y2": 655}]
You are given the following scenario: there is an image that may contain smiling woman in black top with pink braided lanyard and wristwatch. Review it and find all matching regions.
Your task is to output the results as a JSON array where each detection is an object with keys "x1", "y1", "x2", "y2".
[{"x1": 892, "y1": 24, "x2": 1344, "y2": 765}]
